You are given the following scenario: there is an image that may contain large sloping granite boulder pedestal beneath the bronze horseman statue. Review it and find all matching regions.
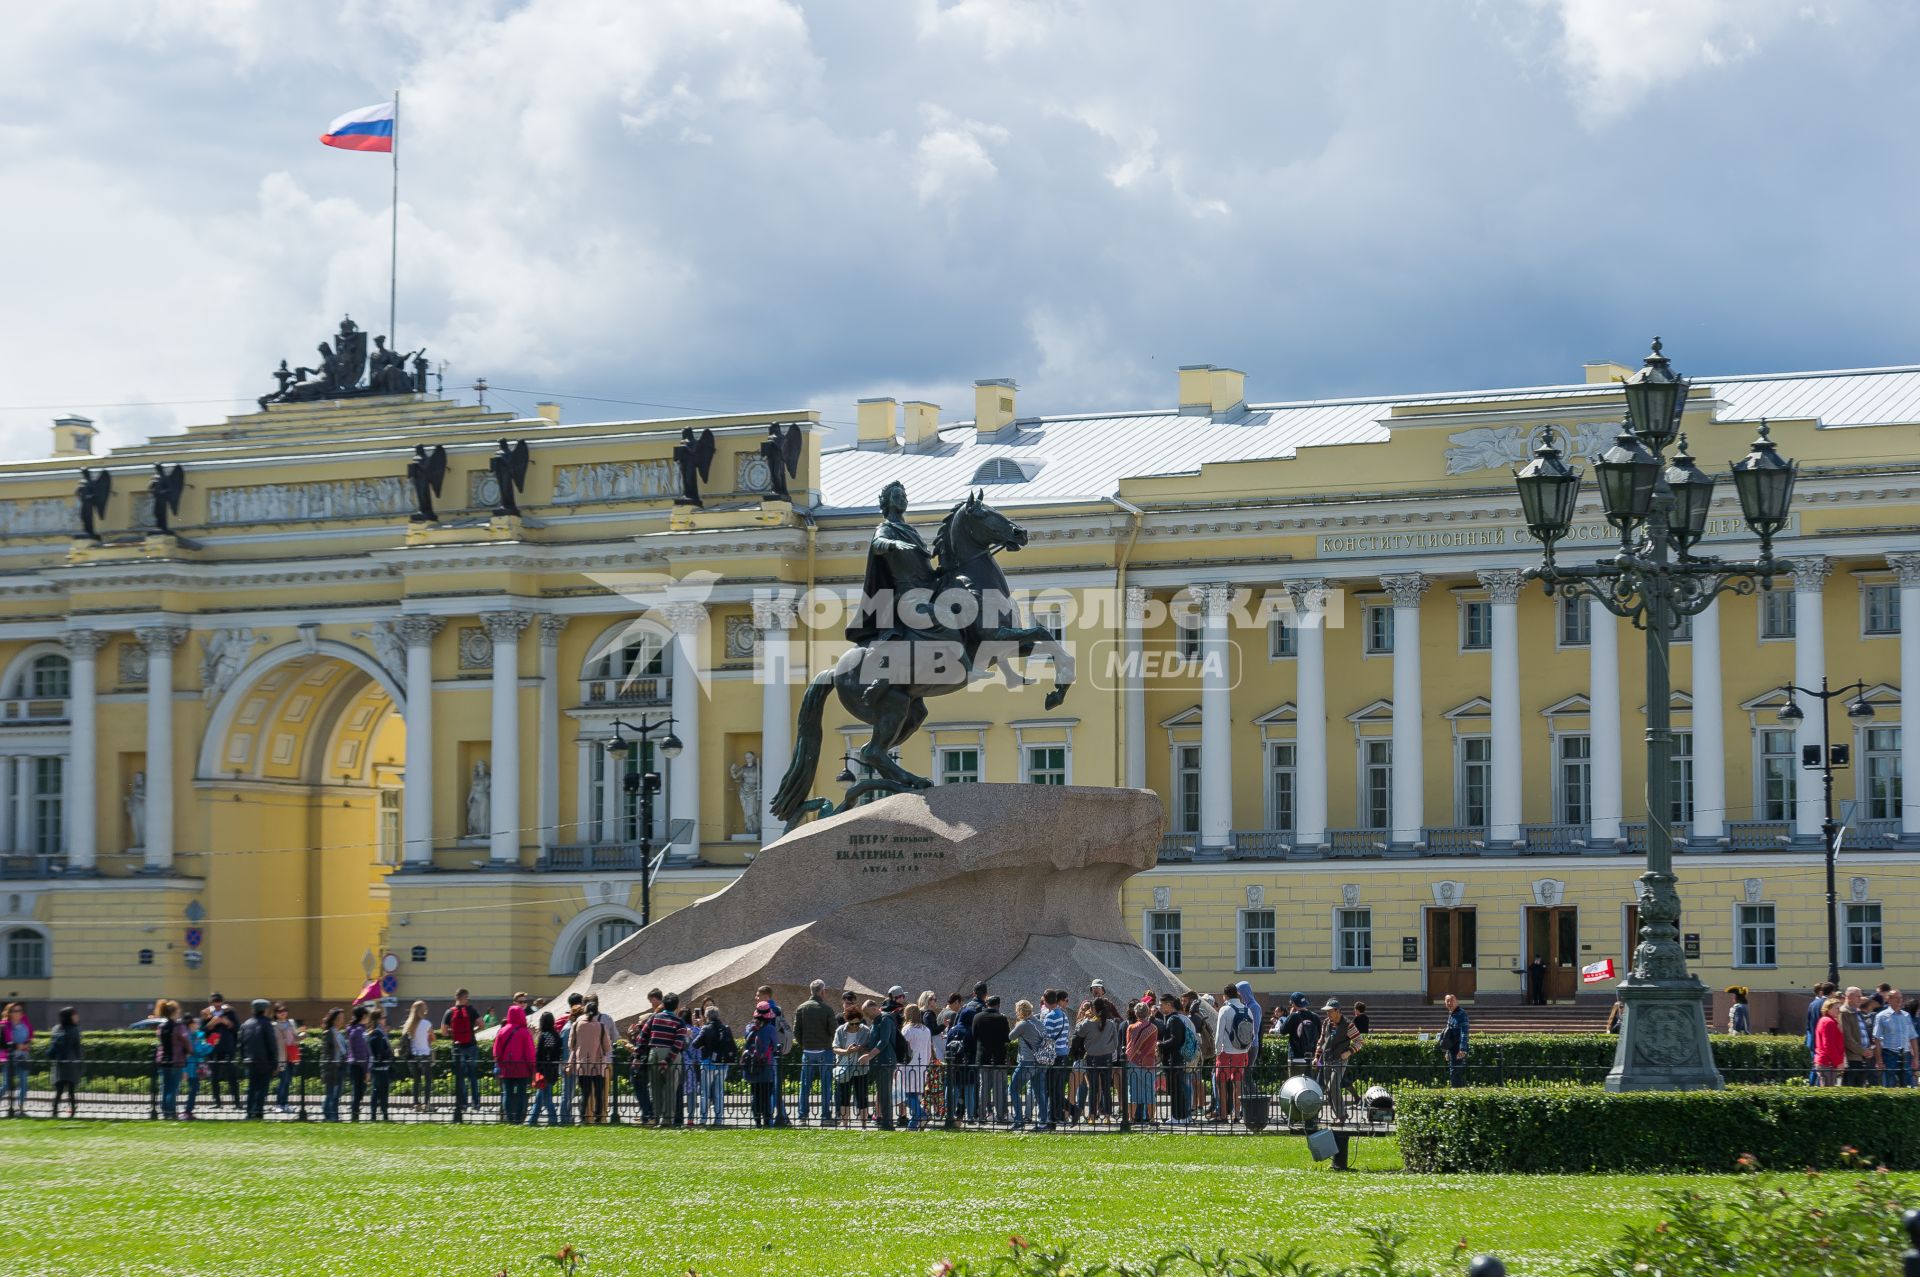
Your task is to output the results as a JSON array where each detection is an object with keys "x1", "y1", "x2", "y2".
[{"x1": 557, "y1": 785, "x2": 1185, "y2": 1025}]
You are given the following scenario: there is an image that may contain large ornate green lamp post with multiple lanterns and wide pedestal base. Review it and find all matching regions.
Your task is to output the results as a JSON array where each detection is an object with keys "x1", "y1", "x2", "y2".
[{"x1": 1515, "y1": 338, "x2": 1795, "y2": 1091}]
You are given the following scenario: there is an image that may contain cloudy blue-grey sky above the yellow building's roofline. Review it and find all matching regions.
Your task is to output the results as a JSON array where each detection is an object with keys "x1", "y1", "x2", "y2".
[{"x1": 0, "y1": 0, "x2": 1920, "y2": 457}]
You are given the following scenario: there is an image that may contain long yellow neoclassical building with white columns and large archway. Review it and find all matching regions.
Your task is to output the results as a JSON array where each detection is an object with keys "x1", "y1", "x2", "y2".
[{"x1": 0, "y1": 341, "x2": 1920, "y2": 1010}]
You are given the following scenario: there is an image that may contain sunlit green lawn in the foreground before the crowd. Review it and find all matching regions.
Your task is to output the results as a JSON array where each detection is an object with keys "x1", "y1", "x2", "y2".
[{"x1": 0, "y1": 1121, "x2": 1843, "y2": 1277}]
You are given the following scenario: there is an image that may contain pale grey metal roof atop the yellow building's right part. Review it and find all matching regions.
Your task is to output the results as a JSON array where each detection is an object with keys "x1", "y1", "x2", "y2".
[{"x1": 820, "y1": 367, "x2": 1920, "y2": 511}]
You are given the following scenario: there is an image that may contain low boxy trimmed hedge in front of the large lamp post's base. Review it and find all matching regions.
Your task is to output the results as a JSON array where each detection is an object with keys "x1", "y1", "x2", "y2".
[{"x1": 1394, "y1": 1087, "x2": 1920, "y2": 1175}]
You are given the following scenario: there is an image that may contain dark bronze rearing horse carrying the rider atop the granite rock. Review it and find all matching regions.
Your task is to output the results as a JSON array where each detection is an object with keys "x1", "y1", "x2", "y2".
[{"x1": 772, "y1": 492, "x2": 1073, "y2": 828}]
